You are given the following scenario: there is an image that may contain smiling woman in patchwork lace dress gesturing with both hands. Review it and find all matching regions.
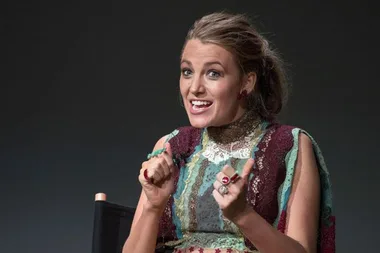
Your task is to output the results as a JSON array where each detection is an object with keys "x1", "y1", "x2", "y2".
[{"x1": 123, "y1": 13, "x2": 335, "y2": 253}]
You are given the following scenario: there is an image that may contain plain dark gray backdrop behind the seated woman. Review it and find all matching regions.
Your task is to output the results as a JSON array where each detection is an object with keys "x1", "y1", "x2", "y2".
[{"x1": 0, "y1": 0, "x2": 380, "y2": 253}]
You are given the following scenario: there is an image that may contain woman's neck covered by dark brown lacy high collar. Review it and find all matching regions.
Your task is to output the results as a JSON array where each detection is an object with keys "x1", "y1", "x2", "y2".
[{"x1": 207, "y1": 111, "x2": 261, "y2": 144}]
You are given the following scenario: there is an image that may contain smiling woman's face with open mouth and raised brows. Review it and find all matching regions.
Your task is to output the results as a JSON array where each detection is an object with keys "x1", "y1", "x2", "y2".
[{"x1": 180, "y1": 40, "x2": 244, "y2": 128}]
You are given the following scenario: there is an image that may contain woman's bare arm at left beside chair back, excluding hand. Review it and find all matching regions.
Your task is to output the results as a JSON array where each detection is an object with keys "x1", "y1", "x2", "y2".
[{"x1": 123, "y1": 136, "x2": 166, "y2": 253}]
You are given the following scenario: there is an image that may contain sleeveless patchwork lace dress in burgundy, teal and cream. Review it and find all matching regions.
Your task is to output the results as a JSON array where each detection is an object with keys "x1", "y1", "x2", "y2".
[{"x1": 151, "y1": 121, "x2": 335, "y2": 253}]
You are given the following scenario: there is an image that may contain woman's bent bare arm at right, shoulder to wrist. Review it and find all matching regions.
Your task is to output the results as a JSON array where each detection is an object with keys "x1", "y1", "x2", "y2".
[{"x1": 235, "y1": 134, "x2": 320, "y2": 253}]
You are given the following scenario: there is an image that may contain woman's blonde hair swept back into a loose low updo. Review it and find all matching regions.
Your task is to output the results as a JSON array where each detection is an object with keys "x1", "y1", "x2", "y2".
[{"x1": 185, "y1": 12, "x2": 288, "y2": 120}]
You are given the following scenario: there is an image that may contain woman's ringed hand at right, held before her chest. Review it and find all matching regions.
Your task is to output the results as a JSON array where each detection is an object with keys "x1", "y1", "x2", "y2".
[{"x1": 212, "y1": 158, "x2": 254, "y2": 222}]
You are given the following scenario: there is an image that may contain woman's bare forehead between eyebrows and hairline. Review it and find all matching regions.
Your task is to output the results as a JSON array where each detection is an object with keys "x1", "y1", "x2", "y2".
[{"x1": 182, "y1": 39, "x2": 234, "y2": 66}]
